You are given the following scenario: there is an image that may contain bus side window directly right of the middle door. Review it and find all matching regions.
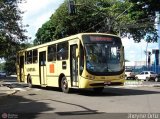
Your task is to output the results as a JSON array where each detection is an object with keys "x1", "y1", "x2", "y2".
[{"x1": 48, "y1": 45, "x2": 56, "y2": 61}]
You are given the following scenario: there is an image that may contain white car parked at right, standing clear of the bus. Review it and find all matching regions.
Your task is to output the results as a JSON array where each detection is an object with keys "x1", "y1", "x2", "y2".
[{"x1": 135, "y1": 71, "x2": 157, "y2": 81}]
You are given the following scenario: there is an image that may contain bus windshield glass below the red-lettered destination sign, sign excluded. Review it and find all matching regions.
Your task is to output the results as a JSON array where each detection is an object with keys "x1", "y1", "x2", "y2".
[{"x1": 85, "y1": 43, "x2": 122, "y2": 73}]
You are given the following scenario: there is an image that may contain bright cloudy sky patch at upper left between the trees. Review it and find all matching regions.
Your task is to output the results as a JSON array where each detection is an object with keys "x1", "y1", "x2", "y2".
[{"x1": 19, "y1": 0, "x2": 64, "y2": 41}]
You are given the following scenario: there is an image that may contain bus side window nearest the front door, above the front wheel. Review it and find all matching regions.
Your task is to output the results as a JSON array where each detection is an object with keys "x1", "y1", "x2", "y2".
[{"x1": 57, "y1": 42, "x2": 68, "y2": 60}]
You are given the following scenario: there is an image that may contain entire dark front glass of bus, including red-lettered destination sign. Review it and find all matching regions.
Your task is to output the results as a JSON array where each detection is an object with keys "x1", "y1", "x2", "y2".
[{"x1": 83, "y1": 35, "x2": 123, "y2": 74}]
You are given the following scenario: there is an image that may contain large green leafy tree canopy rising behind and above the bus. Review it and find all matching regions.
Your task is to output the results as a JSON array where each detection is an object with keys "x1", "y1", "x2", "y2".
[{"x1": 36, "y1": 0, "x2": 158, "y2": 42}]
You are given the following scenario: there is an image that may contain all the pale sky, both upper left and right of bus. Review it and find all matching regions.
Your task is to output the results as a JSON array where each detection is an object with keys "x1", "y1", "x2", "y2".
[{"x1": 19, "y1": 0, "x2": 158, "y2": 61}]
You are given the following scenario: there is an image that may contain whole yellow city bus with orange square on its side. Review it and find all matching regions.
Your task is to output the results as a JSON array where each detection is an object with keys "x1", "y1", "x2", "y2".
[{"x1": 16, "y1": 33, "x2": 125, "y2": 93}]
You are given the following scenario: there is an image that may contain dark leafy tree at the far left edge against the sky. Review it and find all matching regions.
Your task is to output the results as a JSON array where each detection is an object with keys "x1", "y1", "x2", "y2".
[{"x1": 0, "y1": 0, "x2": 27, "y2": 58}]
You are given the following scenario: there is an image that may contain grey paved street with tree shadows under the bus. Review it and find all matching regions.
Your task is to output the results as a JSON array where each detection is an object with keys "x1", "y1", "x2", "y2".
[{"x1": 0, "y1": 77, "x2": 160, "y2": 119}]
